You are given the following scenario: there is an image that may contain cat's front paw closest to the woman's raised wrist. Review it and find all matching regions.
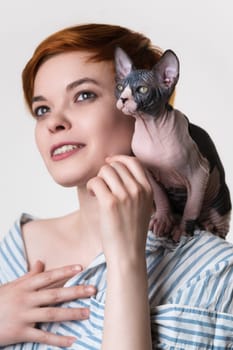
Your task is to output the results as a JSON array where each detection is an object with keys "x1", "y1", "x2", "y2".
[{"x1": 149, "y1": 212, "x2": 174, "y2": 237}]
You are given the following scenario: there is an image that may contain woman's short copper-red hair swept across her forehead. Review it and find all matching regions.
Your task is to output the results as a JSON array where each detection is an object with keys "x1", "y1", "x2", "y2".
[{"x1": 22, "y1": 23, "x2": 161, "y2": 112}]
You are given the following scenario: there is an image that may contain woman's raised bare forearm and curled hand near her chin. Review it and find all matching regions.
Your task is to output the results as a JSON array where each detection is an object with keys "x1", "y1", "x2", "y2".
[{"x1": 87, "y1": 156, "x2": 153, "y2": 350}]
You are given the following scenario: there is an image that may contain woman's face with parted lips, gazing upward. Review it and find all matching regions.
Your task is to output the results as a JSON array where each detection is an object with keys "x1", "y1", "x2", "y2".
[{"x1": 32, "y1": 52, "x2": 134, "y2": 186}]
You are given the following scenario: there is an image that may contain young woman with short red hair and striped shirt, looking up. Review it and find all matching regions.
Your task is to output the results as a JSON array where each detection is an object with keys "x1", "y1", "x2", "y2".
[{"x1": 0, "y1": 24, "x2": 233, "y2": 350}]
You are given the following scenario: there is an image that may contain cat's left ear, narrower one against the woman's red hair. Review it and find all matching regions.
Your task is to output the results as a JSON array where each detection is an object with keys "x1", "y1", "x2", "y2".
[{"x1": 115, "y1": 47, "x2": 133, "y2": 79}]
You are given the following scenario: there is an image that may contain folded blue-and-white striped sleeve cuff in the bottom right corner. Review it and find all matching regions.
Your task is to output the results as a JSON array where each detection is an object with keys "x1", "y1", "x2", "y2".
[{"x1": 151, "y1": 304, "x2": 233, "y2": 350}]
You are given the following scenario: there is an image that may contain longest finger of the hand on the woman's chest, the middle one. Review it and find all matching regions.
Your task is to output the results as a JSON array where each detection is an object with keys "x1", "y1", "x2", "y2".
[{"x1": 28, "y1": 285, "x2": 96, "y2": 306}]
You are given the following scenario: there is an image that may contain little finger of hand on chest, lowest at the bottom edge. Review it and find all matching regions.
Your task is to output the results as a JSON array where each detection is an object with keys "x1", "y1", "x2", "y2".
[{"x1": 26, "y1": 328, "x2": 76, "y2": 348}]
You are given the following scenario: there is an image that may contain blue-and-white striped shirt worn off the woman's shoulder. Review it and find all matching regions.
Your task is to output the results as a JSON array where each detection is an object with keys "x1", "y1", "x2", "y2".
[{"x1": 0, "y1": 214, "x2": 233, "y2": 350}]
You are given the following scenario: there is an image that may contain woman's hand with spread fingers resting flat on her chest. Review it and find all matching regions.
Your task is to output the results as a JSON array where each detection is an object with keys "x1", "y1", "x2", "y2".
[{"x1": 0, "y1": 261, "x2": 95, "y2": 347}]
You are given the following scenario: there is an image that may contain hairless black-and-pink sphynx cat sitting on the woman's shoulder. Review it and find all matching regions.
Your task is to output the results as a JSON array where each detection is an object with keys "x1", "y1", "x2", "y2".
[{"x1": 115, "y1": 48, "x2": 231, "y2": 240}]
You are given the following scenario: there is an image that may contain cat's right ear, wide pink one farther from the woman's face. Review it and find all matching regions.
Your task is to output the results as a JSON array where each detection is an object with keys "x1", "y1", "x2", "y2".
[{"x1": 153, "y1": 50, "x2": 180, "y2": 93}]
